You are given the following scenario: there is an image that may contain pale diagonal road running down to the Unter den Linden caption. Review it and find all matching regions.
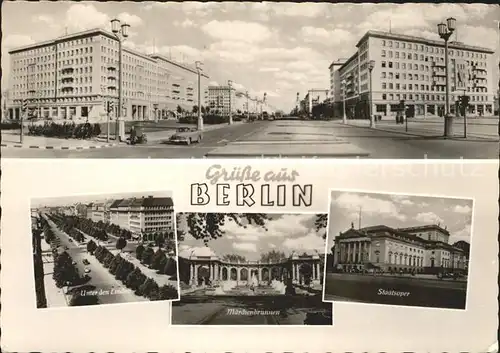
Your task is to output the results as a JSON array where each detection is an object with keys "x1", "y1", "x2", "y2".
[{"x1": 44, "y1": 216, "x2": 147, "y2": 304}]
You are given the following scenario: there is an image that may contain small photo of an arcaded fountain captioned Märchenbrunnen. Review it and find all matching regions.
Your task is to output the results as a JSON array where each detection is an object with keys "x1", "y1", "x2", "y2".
[{"x1": 171, "y1": 213, "x2": 333, "y2": 326}]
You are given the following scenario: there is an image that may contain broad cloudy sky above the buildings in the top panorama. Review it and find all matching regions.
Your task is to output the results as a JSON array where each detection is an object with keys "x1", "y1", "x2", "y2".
[{"x1": 2, "y1": 1, "x2": 500, "y2": 111}]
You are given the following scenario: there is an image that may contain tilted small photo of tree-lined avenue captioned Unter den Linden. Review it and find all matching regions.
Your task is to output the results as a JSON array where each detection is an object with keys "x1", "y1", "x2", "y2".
[{"x1": 31, "y1": 192, "x2": 179, "y2": 308}]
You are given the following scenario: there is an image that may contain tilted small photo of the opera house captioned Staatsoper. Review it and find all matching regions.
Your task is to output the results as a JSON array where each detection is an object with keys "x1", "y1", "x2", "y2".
[{"x1": 324, "y1": 190, "x2": 473, "y2": 310}]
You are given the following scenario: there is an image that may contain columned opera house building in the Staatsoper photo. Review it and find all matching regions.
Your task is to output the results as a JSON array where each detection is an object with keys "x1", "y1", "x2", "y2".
[{"x1": 334, "y1": 224, "x2": 468, "y2": 273}]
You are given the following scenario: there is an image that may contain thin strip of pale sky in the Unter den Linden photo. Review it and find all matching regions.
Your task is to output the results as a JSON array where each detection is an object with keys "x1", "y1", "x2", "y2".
[{"x1": 31, "y1": 191, "x2": 172, "y2": 208}]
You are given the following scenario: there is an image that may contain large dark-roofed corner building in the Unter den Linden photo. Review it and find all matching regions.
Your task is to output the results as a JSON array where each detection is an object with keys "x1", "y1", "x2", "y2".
[{"x1": 109, "y1": 196, "x2": 174, "y2": 240}]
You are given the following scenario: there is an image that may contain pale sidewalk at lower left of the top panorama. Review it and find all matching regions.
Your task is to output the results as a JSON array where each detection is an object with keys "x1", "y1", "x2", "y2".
[{"x1": 1, "y1": 130, "x2": 117, "y2": 150}]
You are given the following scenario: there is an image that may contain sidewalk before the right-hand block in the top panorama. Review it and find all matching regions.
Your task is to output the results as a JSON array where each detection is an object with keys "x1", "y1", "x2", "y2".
[{"x1": 346, "y1": 119, "x2": 498, "y2": 141}]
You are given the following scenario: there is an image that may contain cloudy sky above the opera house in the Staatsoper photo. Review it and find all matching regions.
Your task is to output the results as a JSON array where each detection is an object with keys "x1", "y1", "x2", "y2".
[{"x1": 328, "y1": 191, "x2": 473, "y2": 248}]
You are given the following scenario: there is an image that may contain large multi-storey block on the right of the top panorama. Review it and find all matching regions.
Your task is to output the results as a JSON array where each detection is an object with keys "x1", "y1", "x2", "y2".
[{"x1": 330, "y1": 31, "x2": 495, "y2": 118}]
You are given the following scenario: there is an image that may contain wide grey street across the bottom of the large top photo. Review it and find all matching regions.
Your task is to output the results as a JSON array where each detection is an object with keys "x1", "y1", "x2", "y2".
[{"x1": 2, "y1": 118, "x2": 499, "y2": 159}]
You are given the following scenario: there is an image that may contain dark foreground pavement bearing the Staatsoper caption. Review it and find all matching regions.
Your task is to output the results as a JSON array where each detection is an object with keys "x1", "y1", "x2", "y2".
[{"x1": 324, "y1": 273, "x2": 467, "y2": 309}]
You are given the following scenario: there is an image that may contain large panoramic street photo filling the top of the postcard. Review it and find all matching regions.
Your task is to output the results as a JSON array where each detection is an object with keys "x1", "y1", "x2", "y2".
[{"x1": 1, "y1": 1, "x2": 500, "y2": 159}]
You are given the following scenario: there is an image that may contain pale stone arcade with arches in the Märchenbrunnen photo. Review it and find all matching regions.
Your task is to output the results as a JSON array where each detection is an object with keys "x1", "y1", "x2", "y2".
[{"x1": 179, "y1": 252, "x2": 323, "y2": 286}]
